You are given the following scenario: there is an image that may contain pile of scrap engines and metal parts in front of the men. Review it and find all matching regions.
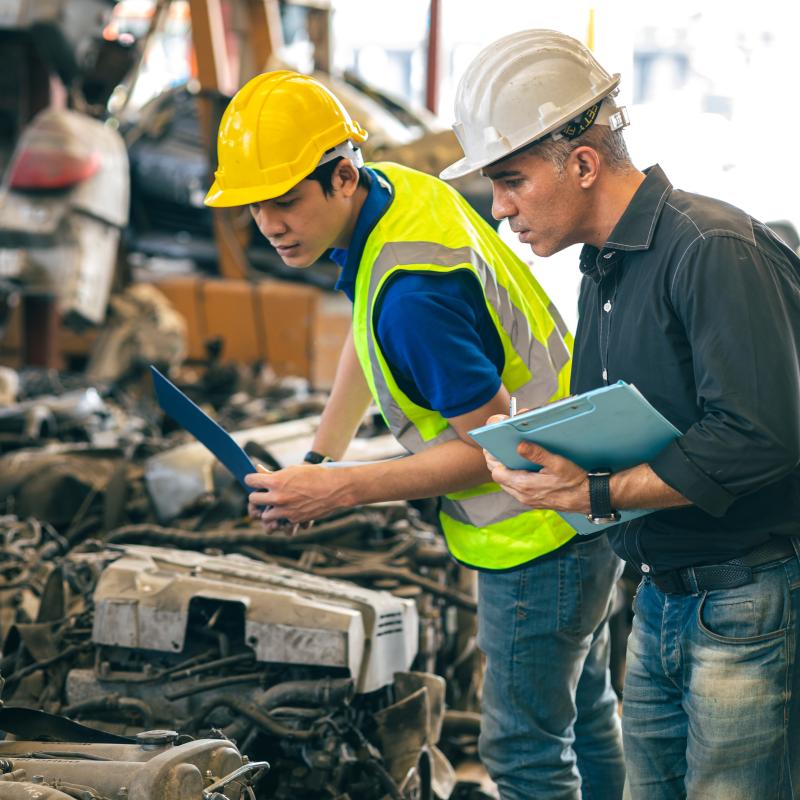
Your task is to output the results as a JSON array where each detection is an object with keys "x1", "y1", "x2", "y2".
[{"x1": 0, "y1": 365, "x2": 484, "y2": 800}]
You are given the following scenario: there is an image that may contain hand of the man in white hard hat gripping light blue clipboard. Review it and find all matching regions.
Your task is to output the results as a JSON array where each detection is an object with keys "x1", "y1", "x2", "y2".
[{"x1": 483, "y1": 415, "x2": 589, "y2": 514}]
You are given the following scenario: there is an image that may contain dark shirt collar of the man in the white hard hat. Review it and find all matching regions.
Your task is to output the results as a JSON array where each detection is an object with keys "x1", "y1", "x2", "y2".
[{"x1": 581, "y1": 164, "x2": 672, "y2": 281}]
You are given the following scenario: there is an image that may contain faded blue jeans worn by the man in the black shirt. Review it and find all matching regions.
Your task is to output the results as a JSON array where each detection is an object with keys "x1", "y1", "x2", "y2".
[{"x1": 622, "y1": 544, "x2": 800, "y2": 800}]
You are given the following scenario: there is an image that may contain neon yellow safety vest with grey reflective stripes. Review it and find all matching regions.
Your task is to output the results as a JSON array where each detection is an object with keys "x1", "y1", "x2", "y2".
[{"x1": 353, "y1": 163, "x2": 575, "y2": 570}]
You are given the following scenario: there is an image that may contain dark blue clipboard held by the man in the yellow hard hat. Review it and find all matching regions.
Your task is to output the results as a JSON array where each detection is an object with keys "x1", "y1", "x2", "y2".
[{"x1": 150, "y1": 365, "x2": 256, "y2": 493}]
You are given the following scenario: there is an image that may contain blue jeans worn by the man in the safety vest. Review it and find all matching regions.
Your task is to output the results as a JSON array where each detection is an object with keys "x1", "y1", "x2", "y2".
[{"x1": 478, "y1": 536, "x2": 625, "y2": 800}]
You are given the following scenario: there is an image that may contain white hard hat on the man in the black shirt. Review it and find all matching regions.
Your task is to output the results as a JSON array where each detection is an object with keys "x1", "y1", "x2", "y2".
[{"x1": 440, "y1": 30, "x2": 628, "y2": 180}]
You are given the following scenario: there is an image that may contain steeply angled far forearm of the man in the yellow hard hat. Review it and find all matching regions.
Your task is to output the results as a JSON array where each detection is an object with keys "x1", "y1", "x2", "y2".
[{"x1": 311, "y1": 331, "x2": 372, "y2": 460}]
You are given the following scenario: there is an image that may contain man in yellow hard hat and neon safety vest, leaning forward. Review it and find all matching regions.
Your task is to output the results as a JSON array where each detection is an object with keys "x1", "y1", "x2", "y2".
[{"x1": 206, "y1": 71, "x2": 623, "y2": 800}]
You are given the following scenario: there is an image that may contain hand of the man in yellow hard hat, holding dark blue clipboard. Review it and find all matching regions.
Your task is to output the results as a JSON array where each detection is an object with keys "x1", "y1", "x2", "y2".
[{"x1": 245, "y1": 464, "x2": 352, "y2": 530}]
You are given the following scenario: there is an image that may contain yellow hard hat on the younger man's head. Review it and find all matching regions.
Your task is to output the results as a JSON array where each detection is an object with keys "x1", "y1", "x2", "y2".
[{"x1": 204, "y1": 70, "x2": 367, "y2": 207}]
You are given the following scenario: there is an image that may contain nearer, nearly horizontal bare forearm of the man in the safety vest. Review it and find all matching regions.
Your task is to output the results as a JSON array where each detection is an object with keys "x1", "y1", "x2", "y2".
[{"x1": 330, "y1": 440, "x2": 491, "y2": 506}]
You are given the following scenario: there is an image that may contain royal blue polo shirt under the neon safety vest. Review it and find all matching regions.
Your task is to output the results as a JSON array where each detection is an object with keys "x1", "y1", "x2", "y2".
[{"x1": 329, "y1": 168, "x2": 504, "y2": 417}]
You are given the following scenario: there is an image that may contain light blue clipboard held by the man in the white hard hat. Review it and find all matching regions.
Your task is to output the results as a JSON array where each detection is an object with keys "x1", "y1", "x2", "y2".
[{"x1": 469, "y1": 381, "x2": 681, "y2": 534}]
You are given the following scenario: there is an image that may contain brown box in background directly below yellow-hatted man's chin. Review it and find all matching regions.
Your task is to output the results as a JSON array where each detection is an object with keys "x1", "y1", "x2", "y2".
[{"x1": 255, "y1": 280, "x2": 322, "y2": 378}]
